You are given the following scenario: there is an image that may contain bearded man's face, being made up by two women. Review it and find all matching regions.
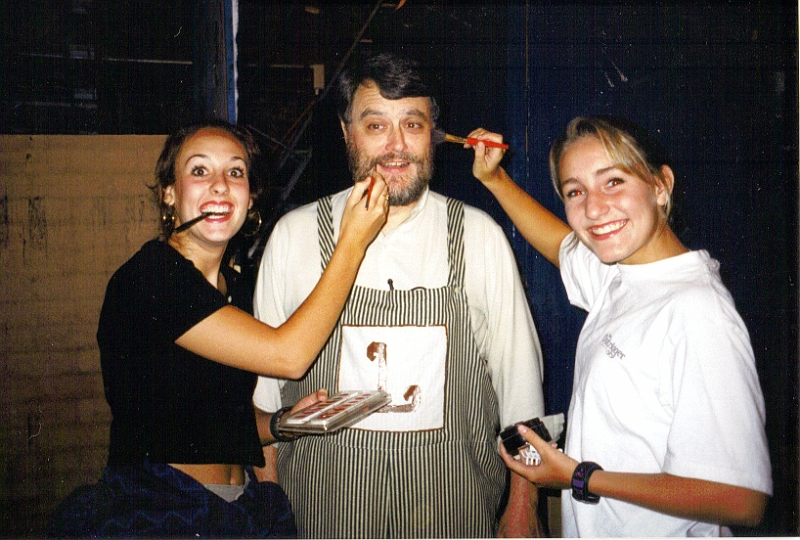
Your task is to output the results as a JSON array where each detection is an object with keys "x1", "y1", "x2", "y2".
[{"x1": 342, "y1": 84, "x2": 433, "y2": 206}]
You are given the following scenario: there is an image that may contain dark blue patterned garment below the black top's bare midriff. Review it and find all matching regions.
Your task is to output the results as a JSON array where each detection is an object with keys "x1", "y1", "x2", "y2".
[{"x1": 47, "y1": 463, "x2": 297, "y2": 538}]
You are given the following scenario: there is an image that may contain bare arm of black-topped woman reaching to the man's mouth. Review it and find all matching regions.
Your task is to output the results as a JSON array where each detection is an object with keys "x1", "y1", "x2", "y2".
[{"x1": 175, "y1": 177, "x2": 388, "y2": 379}]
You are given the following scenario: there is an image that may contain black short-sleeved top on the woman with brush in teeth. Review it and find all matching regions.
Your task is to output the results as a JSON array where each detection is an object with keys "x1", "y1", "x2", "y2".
[{"x1": 97, "y1": 240, "x2": 264, "y2": 466}]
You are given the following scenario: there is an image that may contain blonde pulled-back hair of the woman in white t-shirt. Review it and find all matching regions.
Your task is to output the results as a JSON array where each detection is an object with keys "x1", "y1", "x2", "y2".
[{"x1": 550, "y1": 115, "x2": 672, "y2": 216}]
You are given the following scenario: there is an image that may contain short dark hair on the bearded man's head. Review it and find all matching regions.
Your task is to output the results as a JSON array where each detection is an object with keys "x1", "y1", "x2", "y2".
[{"x1": 336, "y1": 53, "x2": 439, "y2": 125}]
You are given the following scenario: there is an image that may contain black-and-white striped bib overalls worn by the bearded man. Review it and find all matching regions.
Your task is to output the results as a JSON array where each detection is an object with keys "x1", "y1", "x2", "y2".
[{"x1": 278, "y1": 198, "x2": 507, "y2": 538}]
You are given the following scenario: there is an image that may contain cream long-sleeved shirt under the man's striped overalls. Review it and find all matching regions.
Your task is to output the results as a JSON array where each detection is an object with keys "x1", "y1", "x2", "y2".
[{"x1": 253, "y1": 189, "x2": 544, "y2": 427}]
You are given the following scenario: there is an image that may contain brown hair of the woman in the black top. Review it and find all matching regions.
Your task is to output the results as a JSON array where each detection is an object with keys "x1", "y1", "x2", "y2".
[{"x1": 150, "y1": 119, "x2": 263, "y2": 238}]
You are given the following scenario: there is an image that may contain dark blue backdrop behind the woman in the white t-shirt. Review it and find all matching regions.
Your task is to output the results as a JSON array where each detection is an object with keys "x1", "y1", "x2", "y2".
[{"x1": 494, "y1": 3, "x2": 798, "y2": 534}]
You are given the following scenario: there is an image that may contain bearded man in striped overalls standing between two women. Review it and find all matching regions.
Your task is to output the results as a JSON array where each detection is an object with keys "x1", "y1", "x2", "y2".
[{"x1": 254, "y1": 54, "x2": 544, "y2": 538}]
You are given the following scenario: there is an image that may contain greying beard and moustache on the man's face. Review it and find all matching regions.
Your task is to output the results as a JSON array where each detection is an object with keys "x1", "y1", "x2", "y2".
[{"x1": 347, "y1": 138, "x2": 433, "y2": 206}]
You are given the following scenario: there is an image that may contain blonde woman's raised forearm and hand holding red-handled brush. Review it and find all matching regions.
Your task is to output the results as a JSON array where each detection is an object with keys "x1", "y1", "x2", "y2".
[{"x1": 469, "y1": 128, "x2": 571, "y2": 267}]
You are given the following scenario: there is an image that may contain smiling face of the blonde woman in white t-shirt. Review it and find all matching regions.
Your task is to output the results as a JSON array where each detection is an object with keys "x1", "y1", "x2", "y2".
[{"x1": 559, "y1": 135, "x2": 673, "y2": 264}]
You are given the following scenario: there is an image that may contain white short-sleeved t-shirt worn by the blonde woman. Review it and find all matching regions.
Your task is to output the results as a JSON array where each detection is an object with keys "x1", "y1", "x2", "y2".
[{"x1": 559, "y1": 234, "x2": 772, "y2": 537}]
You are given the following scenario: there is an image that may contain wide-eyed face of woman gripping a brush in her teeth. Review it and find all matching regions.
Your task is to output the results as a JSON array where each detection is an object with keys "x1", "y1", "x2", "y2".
[{"x1": 164, "y1": 128, "x2": 253, "y2": 246}]
